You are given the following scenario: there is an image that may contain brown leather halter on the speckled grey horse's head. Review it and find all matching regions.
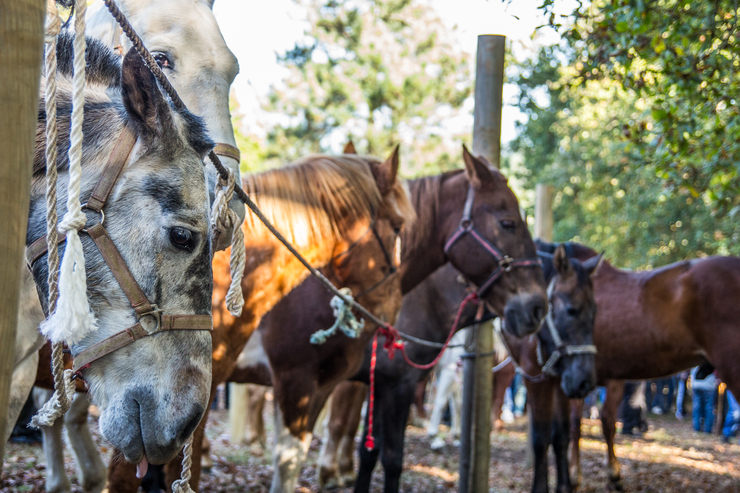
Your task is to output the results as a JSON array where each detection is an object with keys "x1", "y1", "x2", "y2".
[{"x1": 26, "y1": 125, "x2": 213, "y2": 377}]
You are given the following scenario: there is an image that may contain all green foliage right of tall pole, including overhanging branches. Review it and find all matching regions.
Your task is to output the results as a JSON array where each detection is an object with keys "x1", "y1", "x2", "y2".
[{"x1": 512, "y1": 0, "x2": 740, "y2": 267}]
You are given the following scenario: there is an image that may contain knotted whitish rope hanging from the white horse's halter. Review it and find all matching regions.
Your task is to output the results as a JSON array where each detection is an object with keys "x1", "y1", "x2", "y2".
[{"x1": 211, "y1": 170, "x2": 246, "y2": 317}]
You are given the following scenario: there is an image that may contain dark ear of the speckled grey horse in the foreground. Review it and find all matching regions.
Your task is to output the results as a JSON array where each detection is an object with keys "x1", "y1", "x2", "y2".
[{"x1": 121, "y1": 48, "x2": 171, "y2": 135}]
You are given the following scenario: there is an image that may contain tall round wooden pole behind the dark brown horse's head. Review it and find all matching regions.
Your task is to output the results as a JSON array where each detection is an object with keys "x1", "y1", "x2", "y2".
[{"x1": 459, "y1": 35, "x2": 506, "y2": 493}]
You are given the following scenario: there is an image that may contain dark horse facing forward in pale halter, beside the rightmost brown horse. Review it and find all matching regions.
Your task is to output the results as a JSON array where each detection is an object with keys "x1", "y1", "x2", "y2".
[{"x1": 504, "y1": 240, "x2": 601, "y2": 493}]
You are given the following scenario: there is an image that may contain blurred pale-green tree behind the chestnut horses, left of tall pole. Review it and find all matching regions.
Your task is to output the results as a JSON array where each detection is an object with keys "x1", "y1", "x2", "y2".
[{"x1": 266, "y1": 0, "x2": 472, "y2": 174}]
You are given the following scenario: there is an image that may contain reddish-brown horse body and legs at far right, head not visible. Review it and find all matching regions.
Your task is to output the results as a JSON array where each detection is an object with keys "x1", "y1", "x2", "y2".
[{"x1": 560, "y1": 252, "x2": 740, "y2": 488}]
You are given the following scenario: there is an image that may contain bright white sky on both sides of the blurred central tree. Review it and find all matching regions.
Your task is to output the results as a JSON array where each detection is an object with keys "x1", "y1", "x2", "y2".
[{"x1": 214, "y1": 0, "x2": 568, "y2": 142}]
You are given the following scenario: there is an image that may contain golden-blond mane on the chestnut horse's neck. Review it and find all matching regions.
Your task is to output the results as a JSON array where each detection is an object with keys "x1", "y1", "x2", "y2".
[{"x1": 242, "y1": 155, "x2": 390, "y2": 247}]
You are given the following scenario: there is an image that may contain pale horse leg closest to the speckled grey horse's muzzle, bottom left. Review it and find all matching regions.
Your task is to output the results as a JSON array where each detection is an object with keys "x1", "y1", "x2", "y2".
[{"x1": 64, "y1": 392, "x2": 108, "y2": 493}]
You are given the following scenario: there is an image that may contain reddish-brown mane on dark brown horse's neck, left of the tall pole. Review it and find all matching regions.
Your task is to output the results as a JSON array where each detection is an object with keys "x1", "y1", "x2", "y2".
[{"x1": 402, "y1": 169, "x2": 465, "y2": 252}]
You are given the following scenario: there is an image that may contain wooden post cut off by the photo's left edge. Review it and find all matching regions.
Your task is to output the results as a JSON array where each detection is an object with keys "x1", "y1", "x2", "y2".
[{"x1": 0, "y1": 0, "x2": 46, "y2": 457}]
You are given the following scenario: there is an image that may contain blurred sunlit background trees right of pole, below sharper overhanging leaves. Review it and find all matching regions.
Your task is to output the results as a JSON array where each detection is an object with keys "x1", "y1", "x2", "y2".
[{"x1": 511, "y1": 41, "x2": 738, "y2": 268}]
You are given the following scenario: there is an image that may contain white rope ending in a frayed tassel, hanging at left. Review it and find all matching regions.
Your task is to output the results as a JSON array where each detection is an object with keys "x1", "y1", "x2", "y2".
[{"x1": 41, "y1": 0, "x2": 97, "y2": 344}]
